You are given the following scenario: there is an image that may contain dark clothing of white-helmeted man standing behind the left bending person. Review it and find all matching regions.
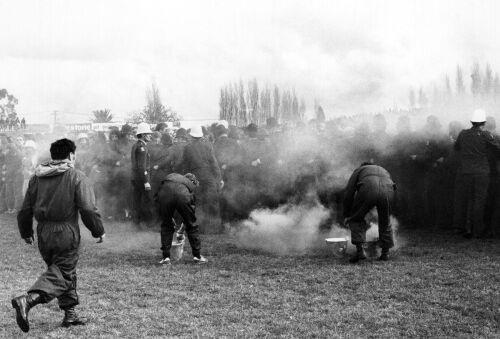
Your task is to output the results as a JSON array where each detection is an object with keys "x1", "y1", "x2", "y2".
[{"x1": 182, "y1": 138, "x2": 222, "y2": 233}]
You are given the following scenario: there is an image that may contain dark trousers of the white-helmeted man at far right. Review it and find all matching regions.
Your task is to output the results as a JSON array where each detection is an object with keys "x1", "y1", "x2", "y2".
[{"x1": 453, "y1": 174, "x2": 490, "y2": 237}]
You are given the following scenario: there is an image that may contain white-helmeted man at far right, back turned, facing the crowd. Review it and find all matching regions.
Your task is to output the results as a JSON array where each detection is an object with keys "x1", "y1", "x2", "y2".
[{"x1": 453, "y1": 109, "x2": 500, "y2": 239}]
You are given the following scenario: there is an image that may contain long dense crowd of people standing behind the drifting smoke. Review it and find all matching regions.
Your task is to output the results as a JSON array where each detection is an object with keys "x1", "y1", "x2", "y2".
[{"x1": 0, "y1": 110, "x2": 500, "y2": 240}]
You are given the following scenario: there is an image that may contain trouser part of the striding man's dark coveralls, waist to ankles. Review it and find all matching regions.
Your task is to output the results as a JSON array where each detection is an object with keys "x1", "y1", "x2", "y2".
[{"x1": 28, "y1": 222, "x2": 80, "y2": 310}]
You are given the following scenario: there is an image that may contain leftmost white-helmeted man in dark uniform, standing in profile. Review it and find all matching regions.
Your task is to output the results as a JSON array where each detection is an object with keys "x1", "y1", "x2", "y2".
[{"x1": 131, "y1": 122, "x2": 153, "y2": 227}]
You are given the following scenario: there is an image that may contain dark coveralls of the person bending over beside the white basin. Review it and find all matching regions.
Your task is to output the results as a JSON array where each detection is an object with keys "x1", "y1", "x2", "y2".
[{"x1": 344, "y1": 165, "x2": 395, "y2": 249}]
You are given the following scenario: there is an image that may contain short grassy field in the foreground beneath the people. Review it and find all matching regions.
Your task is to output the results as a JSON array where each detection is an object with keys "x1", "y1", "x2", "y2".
[{"x1": 0, "y1": 215, "x2": 500, "y2": 338}]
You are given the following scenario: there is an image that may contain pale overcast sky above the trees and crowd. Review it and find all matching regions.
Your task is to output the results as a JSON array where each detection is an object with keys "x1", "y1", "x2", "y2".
[{"x1": 0, "y1": 0, "x2": 500, "y2": 121}]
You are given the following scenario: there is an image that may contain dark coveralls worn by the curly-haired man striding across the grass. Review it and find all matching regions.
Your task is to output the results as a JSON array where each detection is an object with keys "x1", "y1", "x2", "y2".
[{"x1": 17, "y1": 164, "x2": 104, "y2": 310}]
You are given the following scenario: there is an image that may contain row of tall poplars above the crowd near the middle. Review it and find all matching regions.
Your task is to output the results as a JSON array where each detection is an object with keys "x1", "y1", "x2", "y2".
[{"x1": 219, "y1": 79, "x2": 306, "y2": 127}]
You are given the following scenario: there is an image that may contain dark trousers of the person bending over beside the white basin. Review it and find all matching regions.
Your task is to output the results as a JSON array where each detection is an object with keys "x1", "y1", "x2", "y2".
[{"x1": 348, "y1": 185, "x2": 394, "y2": 248}]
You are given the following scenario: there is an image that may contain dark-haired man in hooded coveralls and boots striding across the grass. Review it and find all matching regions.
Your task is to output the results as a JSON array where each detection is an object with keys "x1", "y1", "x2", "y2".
[{"x1": 12, "y1": 139, "x2": 104, "y2": 332}]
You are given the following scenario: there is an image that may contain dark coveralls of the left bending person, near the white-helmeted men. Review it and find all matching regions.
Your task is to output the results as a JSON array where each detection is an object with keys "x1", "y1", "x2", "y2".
[{"x1": 158, "y1": 173, "x2": 201, "y2": 258}]
